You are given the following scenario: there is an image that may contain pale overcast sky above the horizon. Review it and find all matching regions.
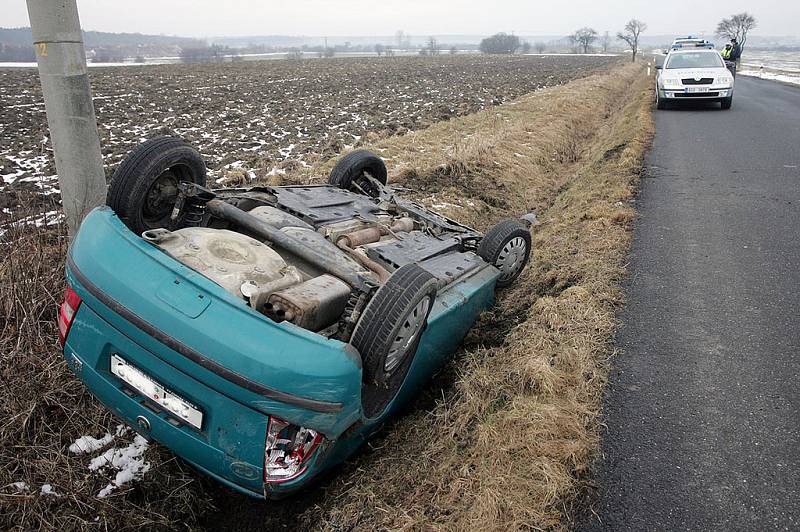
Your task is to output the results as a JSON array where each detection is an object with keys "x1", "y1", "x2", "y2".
[{"x1": 0, "y1": 0, "x2": 800, "y2": 37}]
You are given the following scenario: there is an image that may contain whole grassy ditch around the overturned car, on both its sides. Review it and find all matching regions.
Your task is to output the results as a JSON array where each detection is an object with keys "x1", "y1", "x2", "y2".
[{"x1": 0, "y1": 60, "x2": 652, "y2": 530}]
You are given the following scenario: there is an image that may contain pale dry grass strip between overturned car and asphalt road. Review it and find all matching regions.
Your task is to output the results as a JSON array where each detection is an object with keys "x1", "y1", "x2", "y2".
[{"x1": 290, "y1": 61, "x2": 652, "y2": 530}]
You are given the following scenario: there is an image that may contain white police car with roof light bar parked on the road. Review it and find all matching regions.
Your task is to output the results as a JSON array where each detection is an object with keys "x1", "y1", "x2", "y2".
[{"x1": 656, "y1": 38, "x2": 733, "y2": 109}]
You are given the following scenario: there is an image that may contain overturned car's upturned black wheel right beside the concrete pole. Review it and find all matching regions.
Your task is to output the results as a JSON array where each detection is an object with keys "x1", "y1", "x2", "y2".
[{"x1": 106, "y1": 137, "x2": 206, "y2": 235}]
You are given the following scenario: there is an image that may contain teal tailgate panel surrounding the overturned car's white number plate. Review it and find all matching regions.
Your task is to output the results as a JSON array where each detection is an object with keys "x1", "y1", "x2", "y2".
[{"x1": 64, "y1": 305, "x2": 336, "y2": 499}]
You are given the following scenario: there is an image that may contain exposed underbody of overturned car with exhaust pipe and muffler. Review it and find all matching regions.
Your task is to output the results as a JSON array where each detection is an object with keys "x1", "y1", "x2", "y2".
[{"x1": 143, "y1": 184, "x2": 482, "y2": 342}]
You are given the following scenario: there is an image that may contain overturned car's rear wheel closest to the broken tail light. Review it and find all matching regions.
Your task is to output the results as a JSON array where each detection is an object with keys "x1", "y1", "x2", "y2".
[{"x1": 350, "y1": 264, "x2": 438, "y2": 418}]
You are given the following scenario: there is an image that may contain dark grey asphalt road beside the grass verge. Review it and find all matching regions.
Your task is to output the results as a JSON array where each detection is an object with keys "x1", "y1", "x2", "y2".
[{"x1": 578, "y1": 76, "x2": 800, "y2": 530}]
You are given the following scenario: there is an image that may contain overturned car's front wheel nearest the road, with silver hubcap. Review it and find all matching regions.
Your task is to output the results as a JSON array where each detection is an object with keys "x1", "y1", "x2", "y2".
[{"x1": 478, "y1": 218, "x2": 531, "y2": 288}]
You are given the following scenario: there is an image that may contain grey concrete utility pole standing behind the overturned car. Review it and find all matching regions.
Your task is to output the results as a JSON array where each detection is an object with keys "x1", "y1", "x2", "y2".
[{"x1": 27, "y1": 0, "x2": 106, "y2": 237}]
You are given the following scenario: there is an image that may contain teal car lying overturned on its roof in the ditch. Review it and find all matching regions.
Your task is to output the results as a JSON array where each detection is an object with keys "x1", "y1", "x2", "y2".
[{"x1": 58, "y1": 137, "x2": 531, "y2": 498}]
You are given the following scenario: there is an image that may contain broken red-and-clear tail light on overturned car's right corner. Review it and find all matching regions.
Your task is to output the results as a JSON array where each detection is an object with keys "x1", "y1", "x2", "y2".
[{"x1": 264, "y1": 417, "x2": 322, "y2": 483}]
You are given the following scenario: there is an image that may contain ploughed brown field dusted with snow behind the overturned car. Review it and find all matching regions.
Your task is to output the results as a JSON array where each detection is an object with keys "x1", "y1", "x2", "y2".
[{"x1": 0, "y1": 56, "x2": 618, "y2": 223}]
